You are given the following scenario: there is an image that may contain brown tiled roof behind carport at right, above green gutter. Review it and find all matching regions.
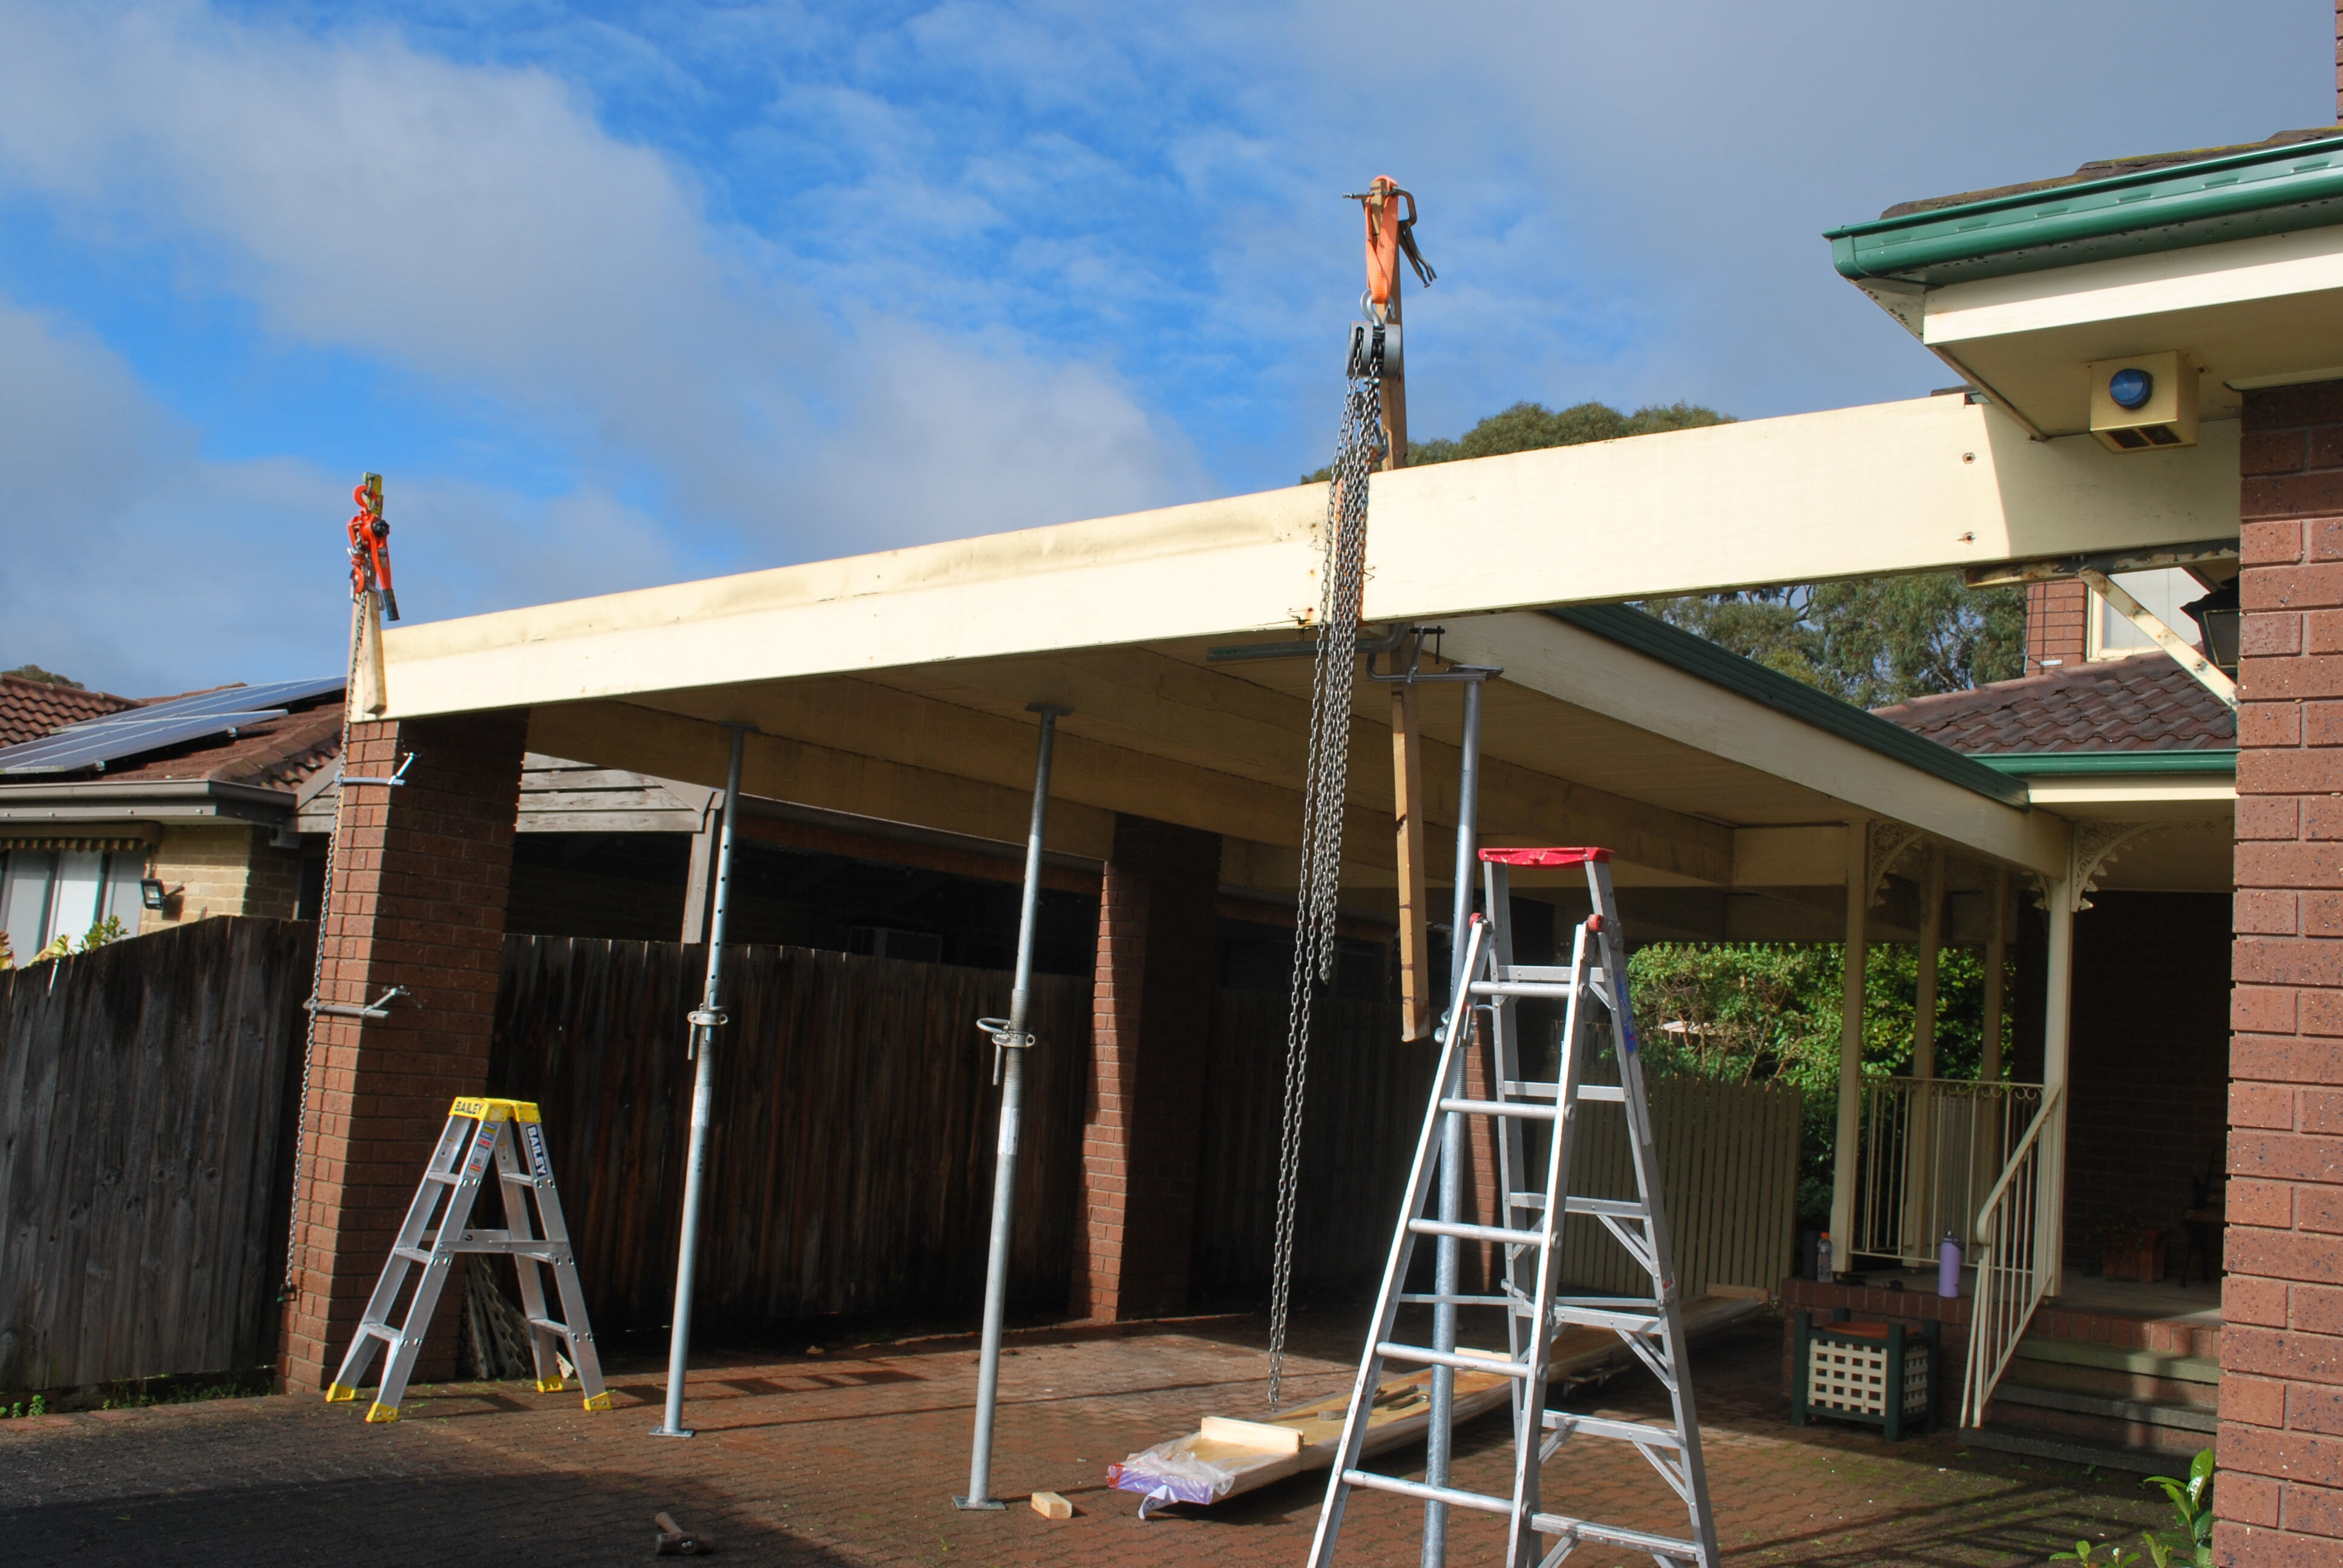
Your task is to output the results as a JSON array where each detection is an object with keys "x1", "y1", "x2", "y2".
[{"x1": 1875, "y1": 652, "x2": 2238, "y2": 755}]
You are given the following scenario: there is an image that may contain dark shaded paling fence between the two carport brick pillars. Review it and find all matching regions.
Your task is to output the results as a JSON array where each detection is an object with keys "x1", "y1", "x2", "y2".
[{"x1": 490, "y1": 938, "x2": 1089, "y2": 1336}]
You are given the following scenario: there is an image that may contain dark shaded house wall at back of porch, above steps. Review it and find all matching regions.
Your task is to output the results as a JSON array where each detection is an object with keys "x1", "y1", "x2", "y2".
[{"x1": 2066, "y1": 893, "x2": 2228, "y2": 1268}]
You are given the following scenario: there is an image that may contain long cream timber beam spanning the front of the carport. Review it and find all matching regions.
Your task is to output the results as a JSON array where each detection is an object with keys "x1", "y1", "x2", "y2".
[{"x1": 384, "y1": 396, "x2": 2238, "y2": 717}]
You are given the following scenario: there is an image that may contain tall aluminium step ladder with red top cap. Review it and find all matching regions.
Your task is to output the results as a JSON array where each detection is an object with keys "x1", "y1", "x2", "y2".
[{"x1": 1309, "y1": 849, "x2": 1717, "y2": 1568}]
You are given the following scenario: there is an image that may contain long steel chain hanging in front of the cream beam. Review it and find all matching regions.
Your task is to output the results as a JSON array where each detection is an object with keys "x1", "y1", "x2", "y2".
[{"x1": 1270, "y1": 326, "x2": 1384, "y2": 1411}]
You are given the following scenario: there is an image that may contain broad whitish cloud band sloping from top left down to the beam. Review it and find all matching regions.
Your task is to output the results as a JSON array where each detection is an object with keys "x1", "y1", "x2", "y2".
[{"x1": 0, "y1": 5, "x2": 1198, "y2": 603}]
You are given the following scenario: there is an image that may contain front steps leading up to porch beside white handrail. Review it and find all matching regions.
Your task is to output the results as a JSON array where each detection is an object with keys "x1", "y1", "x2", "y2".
[{"x1": 1973, "y1": 1338, "x2": 2221, "y2": 1465}]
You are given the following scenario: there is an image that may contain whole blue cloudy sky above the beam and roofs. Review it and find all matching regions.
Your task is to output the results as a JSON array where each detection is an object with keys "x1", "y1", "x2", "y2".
[{"x1": 0, "y1": 0, "x2": 2334, "y2": 694}]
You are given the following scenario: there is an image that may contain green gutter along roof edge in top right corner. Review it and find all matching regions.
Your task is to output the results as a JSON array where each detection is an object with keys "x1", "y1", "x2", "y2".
[{"x1": 1825, "y1": 136, "x2": 2343, "y2": 286}]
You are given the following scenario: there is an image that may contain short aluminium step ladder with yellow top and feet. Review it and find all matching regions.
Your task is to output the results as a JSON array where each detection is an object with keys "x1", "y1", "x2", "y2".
[{"x1": 326, "y1": 1094, "x2": 609, "y2": 1420}]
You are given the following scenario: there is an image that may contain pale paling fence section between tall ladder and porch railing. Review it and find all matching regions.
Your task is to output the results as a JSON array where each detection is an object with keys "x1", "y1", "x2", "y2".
[{"x1": 1556, "y1": 1078, "x2": 1802, "y2": 1296}]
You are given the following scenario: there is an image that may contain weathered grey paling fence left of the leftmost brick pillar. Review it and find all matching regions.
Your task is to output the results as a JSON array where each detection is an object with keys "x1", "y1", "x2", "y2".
[{"x1": 0, "y1": 919, "x2": 314, "y2": 1390}]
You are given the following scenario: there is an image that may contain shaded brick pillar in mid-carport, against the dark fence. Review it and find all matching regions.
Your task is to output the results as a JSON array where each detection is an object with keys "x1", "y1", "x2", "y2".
[{"x1": 1069, "y1": 815, "x2": 1221, "y2": 1322}]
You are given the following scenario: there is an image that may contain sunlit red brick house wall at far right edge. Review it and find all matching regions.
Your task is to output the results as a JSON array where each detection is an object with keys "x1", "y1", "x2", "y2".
[{"x1": 2214, "y1": 382, "x2": 2343, "y2": 1566}]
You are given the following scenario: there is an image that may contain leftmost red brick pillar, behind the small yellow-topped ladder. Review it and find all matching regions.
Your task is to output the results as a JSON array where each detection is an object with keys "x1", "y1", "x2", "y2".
[{"x1": 277, "y1": 713, "x2": 527, "y2": 1390}]
